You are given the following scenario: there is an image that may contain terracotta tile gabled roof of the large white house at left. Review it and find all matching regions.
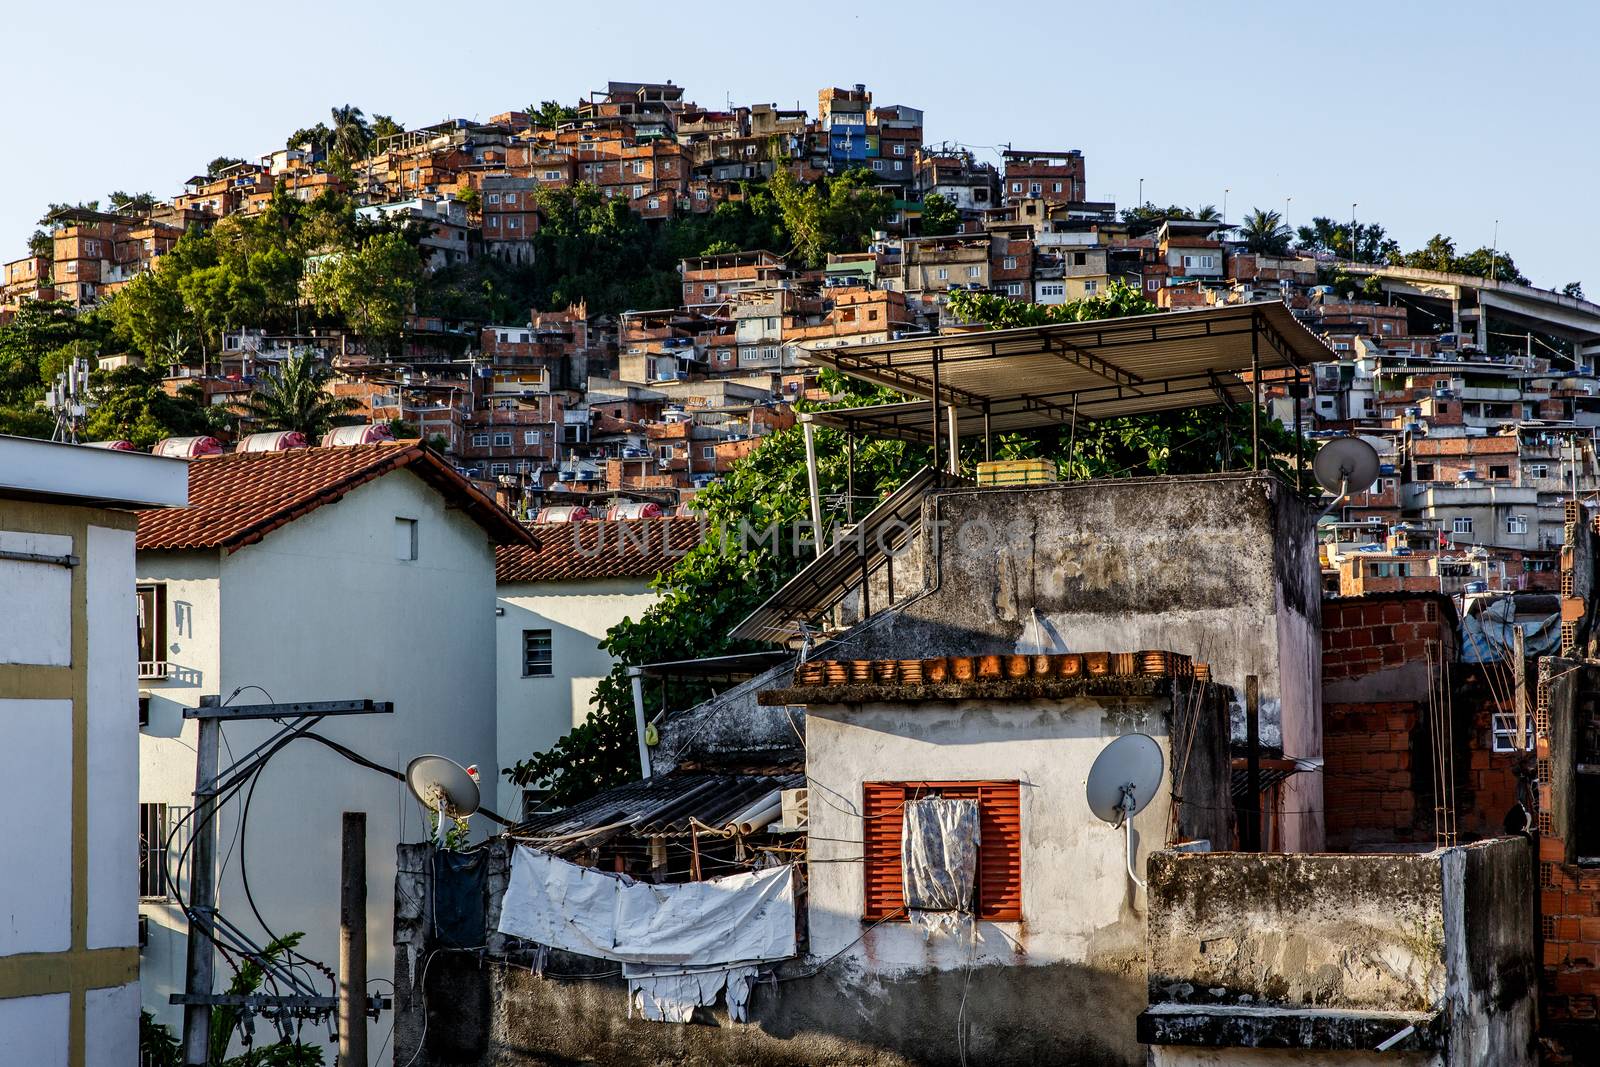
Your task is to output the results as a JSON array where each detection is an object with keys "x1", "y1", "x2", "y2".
[{"x1": 138, "y1": 442, "x2": 536, "y2": 550}]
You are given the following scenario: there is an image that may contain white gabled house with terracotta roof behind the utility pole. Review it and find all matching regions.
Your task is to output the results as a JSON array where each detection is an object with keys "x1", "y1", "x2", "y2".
[{"x1": 128, "y1": 443, "x2": 533, "y2": 1062}]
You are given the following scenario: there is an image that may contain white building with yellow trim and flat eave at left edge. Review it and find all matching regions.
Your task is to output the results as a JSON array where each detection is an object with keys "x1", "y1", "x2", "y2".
[{"x1": 0, "y1": 437, "x2": 186, "y2": 1067}]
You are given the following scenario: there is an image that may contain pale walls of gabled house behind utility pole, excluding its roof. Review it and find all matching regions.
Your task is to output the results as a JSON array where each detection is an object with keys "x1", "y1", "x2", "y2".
[{"x1": 139, "y1": 470, "x2": 498, "y2": 1062}]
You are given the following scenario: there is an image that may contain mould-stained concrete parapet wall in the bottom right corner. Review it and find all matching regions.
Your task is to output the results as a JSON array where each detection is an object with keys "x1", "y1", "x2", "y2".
[{"x1": 1141, "y1": 838, "x2": 1538, "y2": 1065}]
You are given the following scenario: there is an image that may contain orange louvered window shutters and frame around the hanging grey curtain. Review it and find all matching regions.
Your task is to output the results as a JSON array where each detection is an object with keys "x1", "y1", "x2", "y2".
[{"x1": 861, "y1": 782, "x2": 1022, "y2": 923}]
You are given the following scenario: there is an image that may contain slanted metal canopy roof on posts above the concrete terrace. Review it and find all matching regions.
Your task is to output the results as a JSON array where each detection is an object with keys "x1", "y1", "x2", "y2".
[{"x1": 806, "y1": 301, "x2": 1338, "y2": 437}]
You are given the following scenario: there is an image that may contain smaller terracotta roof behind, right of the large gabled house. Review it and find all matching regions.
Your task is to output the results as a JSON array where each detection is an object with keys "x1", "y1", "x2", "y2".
[{"x1": 494, "y1": 517, "x2": 704, "y2": 582}]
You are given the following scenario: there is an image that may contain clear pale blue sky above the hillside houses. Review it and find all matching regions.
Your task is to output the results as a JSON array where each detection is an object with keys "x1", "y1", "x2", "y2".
[{"x1": 0, "y1": 0, "x2": 1600, "y2": 289}]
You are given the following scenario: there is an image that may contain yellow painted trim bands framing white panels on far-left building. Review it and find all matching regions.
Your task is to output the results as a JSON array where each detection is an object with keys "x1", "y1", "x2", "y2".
[{"x1": 0, "y1": 501, "x2": 139, "y2": 1067}]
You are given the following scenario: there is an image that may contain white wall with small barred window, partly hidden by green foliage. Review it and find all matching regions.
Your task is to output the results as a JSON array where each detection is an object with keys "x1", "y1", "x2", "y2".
[{"x1": 483, "y1": 577, "x2": 656, "y2": 817}]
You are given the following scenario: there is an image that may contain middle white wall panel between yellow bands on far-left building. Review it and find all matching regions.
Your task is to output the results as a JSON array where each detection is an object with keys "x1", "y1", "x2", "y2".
[{"x1": 0, "y1": 700, "x2": 73, "y2": 959}]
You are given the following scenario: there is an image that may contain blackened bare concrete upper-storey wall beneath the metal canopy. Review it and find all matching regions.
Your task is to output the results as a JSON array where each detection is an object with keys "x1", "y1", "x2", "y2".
[{"x1": 851, "y1": 474, "x2": 1323, "y2": 851}]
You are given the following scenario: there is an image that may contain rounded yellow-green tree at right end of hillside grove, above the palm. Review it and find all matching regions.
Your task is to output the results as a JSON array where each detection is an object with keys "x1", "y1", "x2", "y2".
[{"x1": 310, "y1": 230, "x2": 422, "y2": 355}]
